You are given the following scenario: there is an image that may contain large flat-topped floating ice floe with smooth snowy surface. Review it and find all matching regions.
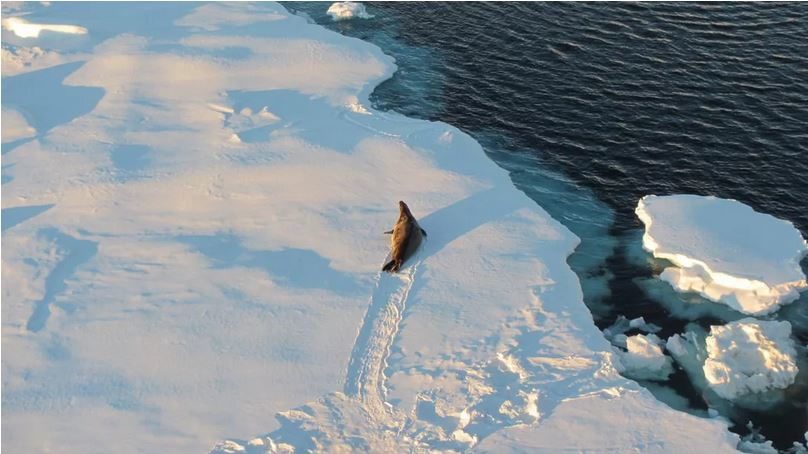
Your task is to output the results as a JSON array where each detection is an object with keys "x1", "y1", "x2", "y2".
[{"x1": 636, "y1": 194, "x2": 808, "y2": 315}]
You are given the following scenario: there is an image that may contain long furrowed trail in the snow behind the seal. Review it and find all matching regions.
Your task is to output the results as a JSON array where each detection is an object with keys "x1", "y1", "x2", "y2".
[{"x1": 345, "y1": 261, "x2": 420, "y2": 419}]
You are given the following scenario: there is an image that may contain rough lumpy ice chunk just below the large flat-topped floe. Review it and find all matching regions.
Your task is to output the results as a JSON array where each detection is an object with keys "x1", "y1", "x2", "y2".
[{"x1": 704, "y1": 317, "x2": 797, "y2": 399}]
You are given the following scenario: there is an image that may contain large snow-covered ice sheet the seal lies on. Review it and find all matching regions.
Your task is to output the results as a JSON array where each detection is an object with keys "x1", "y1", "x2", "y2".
[{"x1": 0, "y1": 2, "x2": 739, "y2": 453}]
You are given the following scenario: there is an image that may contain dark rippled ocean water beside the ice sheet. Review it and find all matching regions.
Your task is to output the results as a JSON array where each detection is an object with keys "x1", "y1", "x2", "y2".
[{"x1": 285, "y1": 3, "x2": 808, "y2": 449}]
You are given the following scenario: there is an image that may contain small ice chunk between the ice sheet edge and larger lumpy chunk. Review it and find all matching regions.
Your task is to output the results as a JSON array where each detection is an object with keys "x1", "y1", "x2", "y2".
[{"x1": 618, "y1": 334, "x2": 673, "y2": 380}]
